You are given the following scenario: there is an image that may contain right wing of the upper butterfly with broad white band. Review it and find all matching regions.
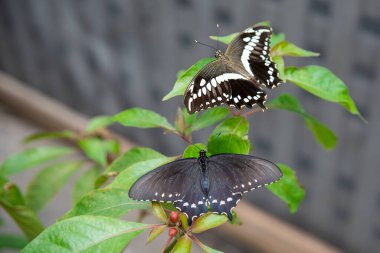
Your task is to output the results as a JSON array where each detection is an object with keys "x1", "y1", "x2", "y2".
[{"x1": 226, "y1": 26, "x2": 281, "y2": 89}]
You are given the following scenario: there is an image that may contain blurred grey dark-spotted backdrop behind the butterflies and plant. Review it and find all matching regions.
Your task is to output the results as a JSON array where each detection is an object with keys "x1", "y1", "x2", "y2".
[{"x1": 0, "y1": 0, "x2": 380, "y2": 252}]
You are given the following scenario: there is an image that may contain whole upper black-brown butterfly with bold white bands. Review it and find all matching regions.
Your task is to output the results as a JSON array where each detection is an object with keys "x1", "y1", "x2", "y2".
[{"x1": 184, "y1": 26, "x2": 282, "y2": 113}]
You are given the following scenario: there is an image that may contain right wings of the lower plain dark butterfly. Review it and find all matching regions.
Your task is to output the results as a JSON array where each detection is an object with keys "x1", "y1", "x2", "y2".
[{"x1": 208, "y1": 154, "x2": 282, "y2": 219}]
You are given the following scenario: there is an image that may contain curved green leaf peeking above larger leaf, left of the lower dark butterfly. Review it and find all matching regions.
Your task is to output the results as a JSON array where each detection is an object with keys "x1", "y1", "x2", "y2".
[{"x1": 105, "y1": 147, "x2": 165, "y2": 172}]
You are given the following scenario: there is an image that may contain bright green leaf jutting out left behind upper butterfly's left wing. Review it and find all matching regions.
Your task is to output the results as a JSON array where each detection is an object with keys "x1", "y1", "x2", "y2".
[{"x1": 162, "y1": 58, "x2": 215, "y2": 101}]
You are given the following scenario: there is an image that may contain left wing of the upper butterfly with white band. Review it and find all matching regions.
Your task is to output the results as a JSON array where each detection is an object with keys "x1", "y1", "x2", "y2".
[{"x1": 184, "y1": 59, "x2": 266, "y2": 113}]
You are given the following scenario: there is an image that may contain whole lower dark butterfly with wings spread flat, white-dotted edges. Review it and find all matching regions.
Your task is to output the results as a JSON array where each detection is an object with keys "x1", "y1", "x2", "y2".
[{"x1": 129, "y1": 150, "x2": 282, "y2": 225}]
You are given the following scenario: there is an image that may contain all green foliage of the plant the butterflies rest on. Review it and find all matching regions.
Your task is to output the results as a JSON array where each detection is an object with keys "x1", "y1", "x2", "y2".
[{"x1": 0, "y1": 22, "x2": 360, "y2": 253}]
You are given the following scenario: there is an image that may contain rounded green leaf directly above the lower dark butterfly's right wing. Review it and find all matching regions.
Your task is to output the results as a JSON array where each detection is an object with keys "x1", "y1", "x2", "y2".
[{"x1": 207, "y1": 116, "x2": 251, "y2": 154}]
